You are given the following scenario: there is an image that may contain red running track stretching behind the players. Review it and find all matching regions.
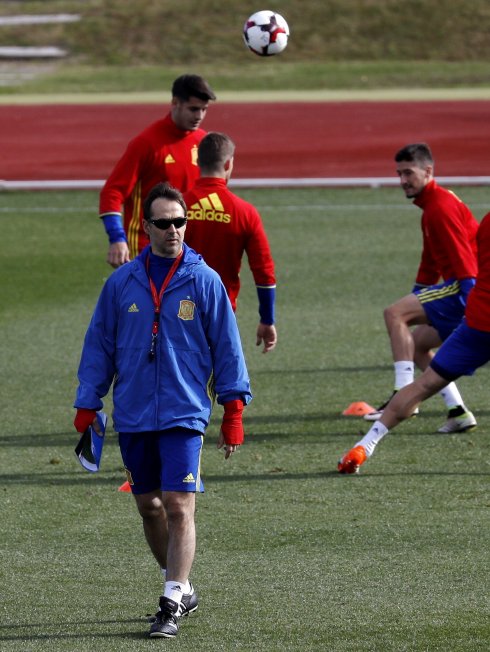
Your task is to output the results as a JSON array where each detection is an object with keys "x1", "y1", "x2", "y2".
[{"x1": 0, "y1": 100, "x2": 490, "y2": 181}]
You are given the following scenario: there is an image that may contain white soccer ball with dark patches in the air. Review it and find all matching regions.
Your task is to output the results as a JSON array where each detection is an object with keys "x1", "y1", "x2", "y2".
[{"x1": 243, "y1": 10, "x2": 289, "y2": 57}]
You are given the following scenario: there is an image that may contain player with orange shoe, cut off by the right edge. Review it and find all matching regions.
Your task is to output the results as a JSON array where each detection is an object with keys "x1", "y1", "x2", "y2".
[{"x1": 338, "y1": 213, "x2": 490, "y2": 473}]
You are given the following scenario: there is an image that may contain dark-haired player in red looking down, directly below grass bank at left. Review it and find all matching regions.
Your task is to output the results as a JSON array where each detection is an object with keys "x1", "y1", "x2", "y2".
[{"x1": 99, "y1": 75, "x2": 216, "y2": 267}]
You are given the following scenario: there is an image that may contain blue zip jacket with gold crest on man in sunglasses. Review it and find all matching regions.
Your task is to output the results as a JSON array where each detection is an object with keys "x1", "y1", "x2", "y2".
[{"x1": 75, "y1": 244, "x2": 252, "y2": 433}]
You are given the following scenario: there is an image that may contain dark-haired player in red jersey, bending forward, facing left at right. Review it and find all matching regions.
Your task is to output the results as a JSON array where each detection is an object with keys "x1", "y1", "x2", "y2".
[{"x1": 364, "y1": 143, "x2": 478, "y2": 433}]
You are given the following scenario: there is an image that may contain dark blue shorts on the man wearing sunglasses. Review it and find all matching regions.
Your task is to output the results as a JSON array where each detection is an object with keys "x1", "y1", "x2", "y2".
[{"x1": 119, "y1": 428, "x2": 204, "y2": 494}]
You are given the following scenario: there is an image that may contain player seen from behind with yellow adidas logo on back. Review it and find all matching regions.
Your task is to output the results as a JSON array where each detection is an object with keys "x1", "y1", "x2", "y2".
[{"x1": 184, "y1": 132, "x2": 277, "y2": 353}]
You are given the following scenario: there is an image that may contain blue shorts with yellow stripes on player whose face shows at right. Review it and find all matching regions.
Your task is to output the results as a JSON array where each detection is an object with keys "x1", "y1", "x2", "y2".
[{"x1": 414, "y1": 280, "x2": 467, "y2": 342}]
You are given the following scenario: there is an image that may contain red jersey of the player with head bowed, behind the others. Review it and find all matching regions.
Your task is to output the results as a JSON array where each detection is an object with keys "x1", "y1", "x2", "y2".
[{"x1": 99, "y1": 113, "x2": 206, "y2": 258}]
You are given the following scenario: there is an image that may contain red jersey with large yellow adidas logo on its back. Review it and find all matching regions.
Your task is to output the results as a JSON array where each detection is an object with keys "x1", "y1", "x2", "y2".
[{"x1": 184, "y1": 177, "x2": 276, "y2": 310}]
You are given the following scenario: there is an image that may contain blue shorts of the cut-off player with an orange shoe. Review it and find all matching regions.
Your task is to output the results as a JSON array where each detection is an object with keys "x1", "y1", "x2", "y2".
[{"x1": 430, "y1": 321, "x2": 490, "y2": 381}]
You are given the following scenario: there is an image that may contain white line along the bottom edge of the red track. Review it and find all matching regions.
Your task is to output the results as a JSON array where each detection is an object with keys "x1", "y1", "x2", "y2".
[{"x1": 0, "y1": 176, "x2": 490, "y2": 191}]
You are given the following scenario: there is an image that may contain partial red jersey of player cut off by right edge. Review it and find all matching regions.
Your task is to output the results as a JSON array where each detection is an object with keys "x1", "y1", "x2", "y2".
[{"x1": 465, "y1": 213, "x2": 490, "y2": 332}]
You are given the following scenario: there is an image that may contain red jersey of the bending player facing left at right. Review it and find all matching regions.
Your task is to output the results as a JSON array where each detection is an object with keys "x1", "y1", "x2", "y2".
[{"x1": 413, "y1": 180, "x2": 478, "y2": 285}]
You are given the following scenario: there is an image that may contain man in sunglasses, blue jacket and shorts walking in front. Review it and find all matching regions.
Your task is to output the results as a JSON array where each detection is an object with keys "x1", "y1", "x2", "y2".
[{"x1": 75, "y1": 183, "x2": 252, "y2": 638}]
